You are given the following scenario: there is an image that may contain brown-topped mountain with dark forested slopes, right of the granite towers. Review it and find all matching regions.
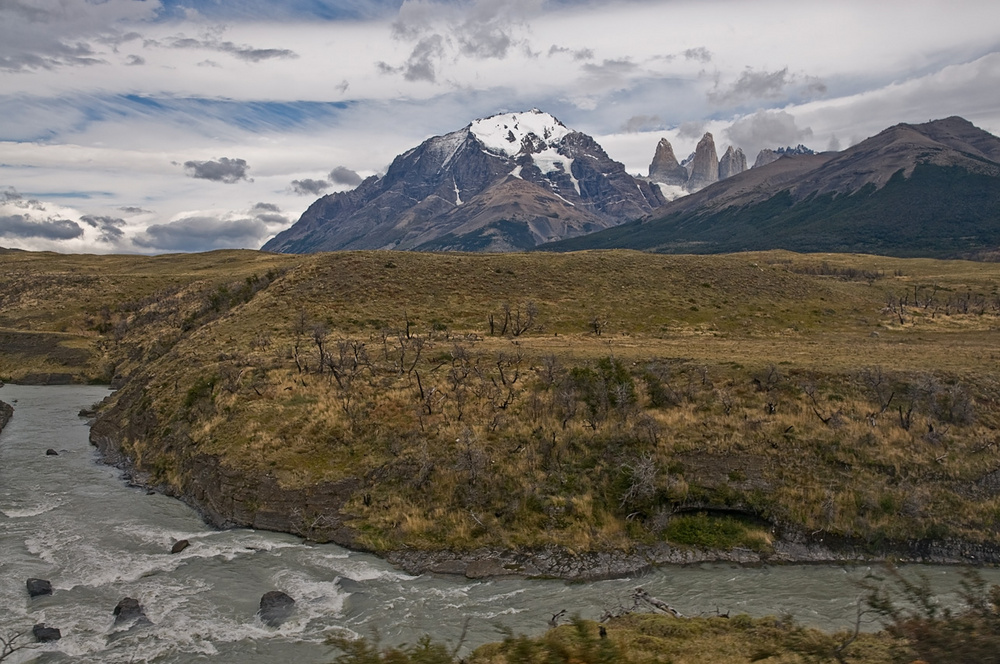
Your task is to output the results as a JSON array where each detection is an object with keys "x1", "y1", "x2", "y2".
[{"x1": 544, "y1": 117, "x2": 1000, "y2": 257}]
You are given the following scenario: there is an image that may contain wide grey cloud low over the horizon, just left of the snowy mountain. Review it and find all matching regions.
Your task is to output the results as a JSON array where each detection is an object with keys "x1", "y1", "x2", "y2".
[{"x1": 132, "y1": 217, "x2": 269, "y2": 251}]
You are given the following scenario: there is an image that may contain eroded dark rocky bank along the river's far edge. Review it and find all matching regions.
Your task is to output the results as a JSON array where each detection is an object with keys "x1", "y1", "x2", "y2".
[{"x1": 90, "y1": 408, "x2": 1000, "y2": 582}]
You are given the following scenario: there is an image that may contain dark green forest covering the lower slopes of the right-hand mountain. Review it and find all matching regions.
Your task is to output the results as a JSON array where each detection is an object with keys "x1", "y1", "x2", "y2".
[{"x1": 542, "y1": 164, "x2": 1000, "y2": 258}]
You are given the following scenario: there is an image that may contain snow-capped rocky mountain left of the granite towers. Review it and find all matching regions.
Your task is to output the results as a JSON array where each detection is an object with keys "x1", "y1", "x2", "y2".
[{"x1": 263, "y1": 109, "x2": 666, "y2": 253}]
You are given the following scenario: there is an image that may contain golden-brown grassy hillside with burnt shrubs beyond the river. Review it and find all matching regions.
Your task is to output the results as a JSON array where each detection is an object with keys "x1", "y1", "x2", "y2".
[{"x1": 0, "y1": 252, "x2": 1000, "y2": 576}]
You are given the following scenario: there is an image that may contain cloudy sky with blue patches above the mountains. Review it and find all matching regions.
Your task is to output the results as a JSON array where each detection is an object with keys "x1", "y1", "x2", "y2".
[{"x1": 0, "y1": 0, "x2": 1000, "y2": 254}]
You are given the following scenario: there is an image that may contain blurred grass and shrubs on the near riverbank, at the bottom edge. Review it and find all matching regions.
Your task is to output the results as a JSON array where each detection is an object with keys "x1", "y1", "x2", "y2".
[{"x1": 331, "y1": 569, "x2": 1000, "y2": 664}]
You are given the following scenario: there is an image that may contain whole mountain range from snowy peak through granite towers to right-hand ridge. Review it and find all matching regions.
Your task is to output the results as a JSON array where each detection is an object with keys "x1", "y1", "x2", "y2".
[{"x1": 263, "y1": 109, "x2": 1000, "y2": 257}]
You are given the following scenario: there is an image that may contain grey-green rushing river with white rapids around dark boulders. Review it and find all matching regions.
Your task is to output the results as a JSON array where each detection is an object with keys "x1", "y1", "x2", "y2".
[{"x1": 0, "y1": 385, "x2": 1000, "y2": 664}]
